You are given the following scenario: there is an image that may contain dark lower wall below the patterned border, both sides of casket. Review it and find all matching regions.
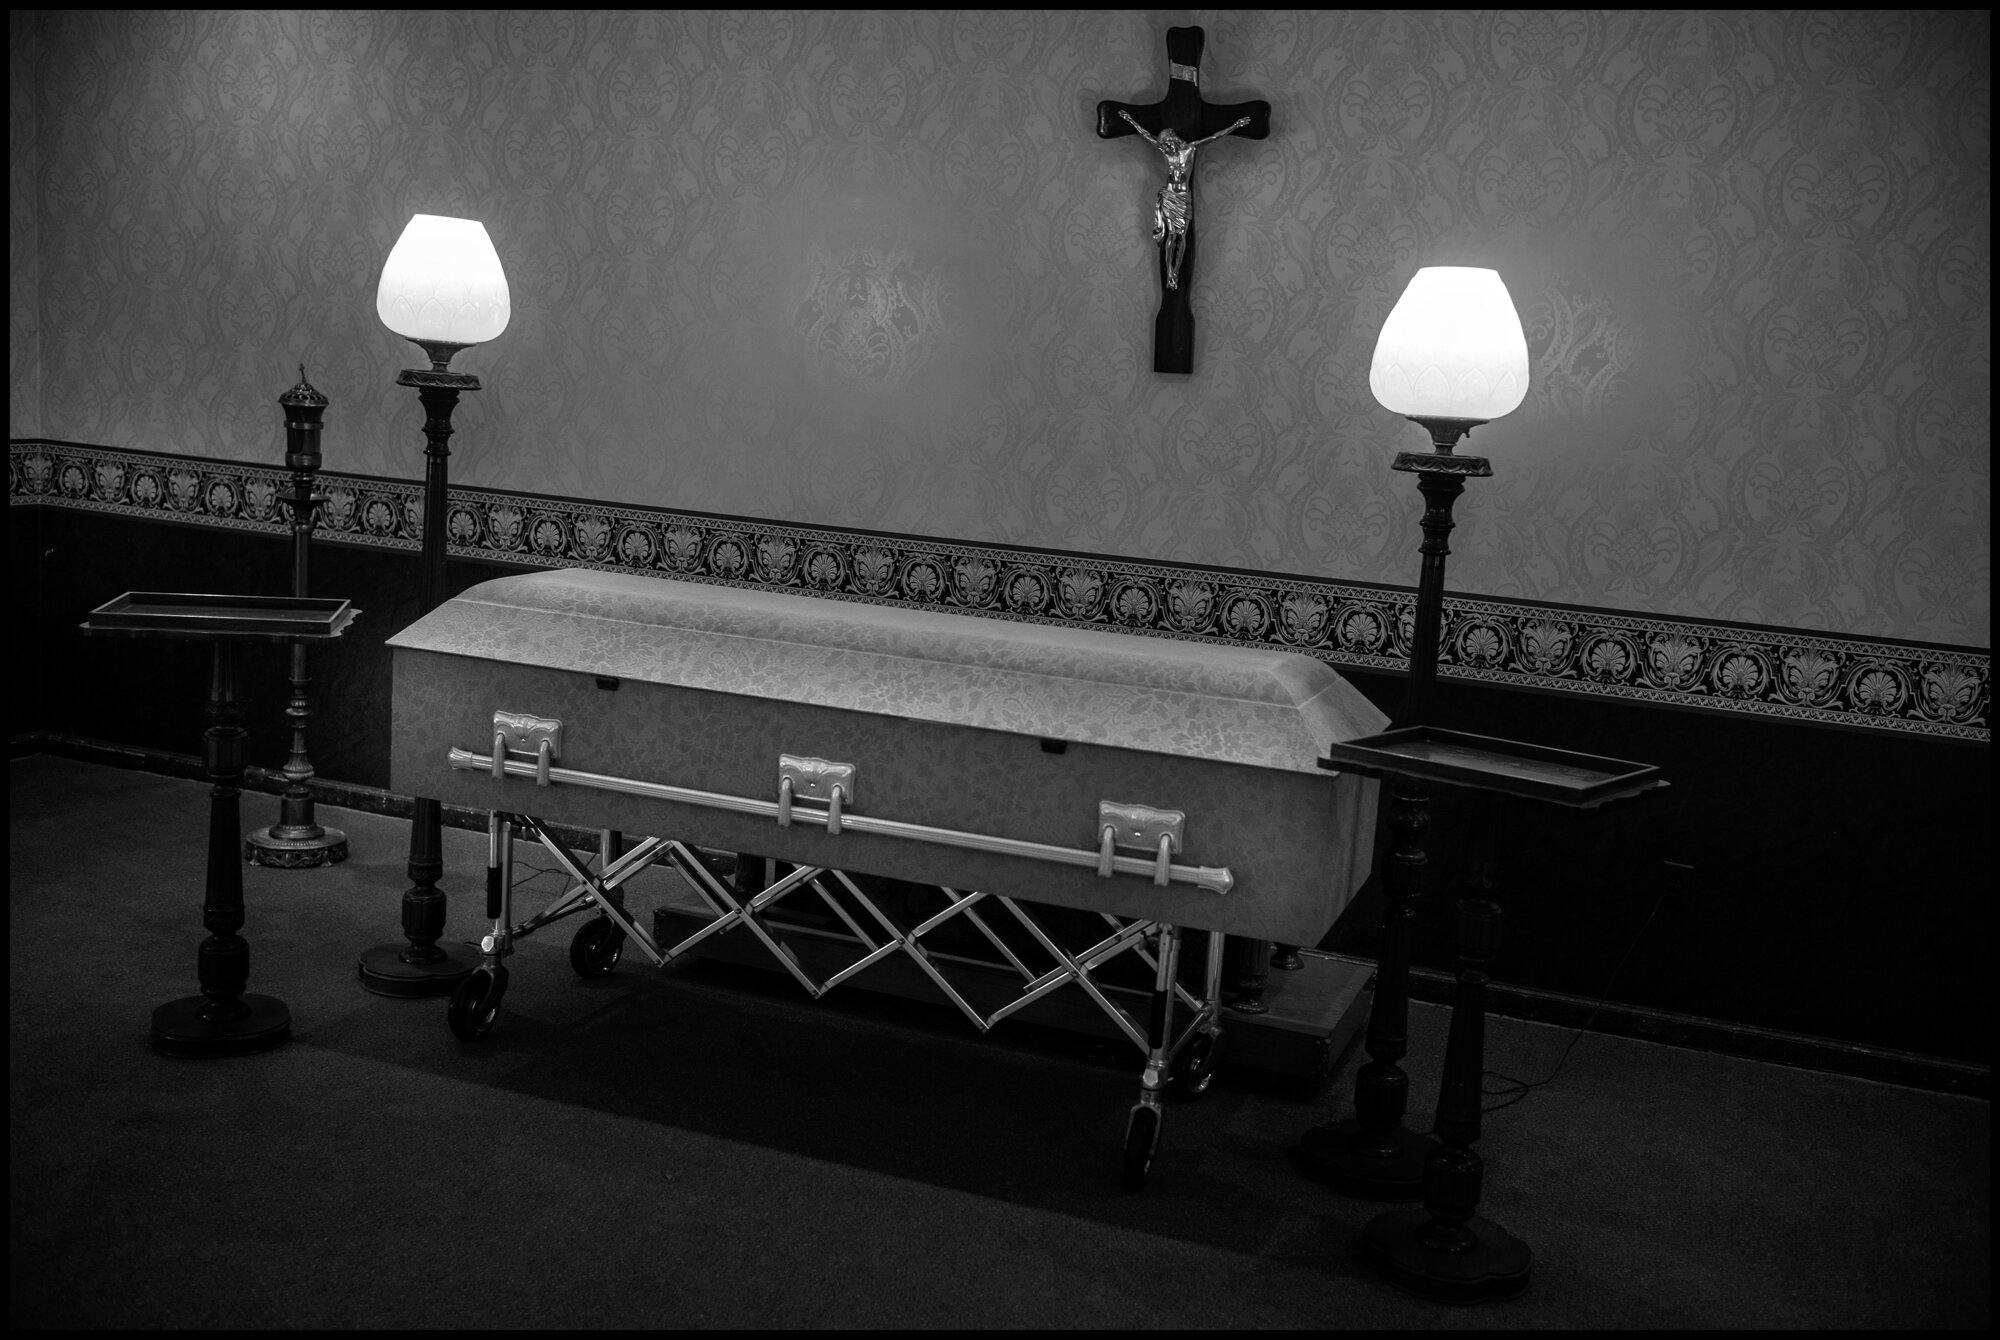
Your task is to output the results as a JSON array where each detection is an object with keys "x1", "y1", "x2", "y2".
[{"x1": 8, "y1": 498, "x2": 1992, "y2": 1078}]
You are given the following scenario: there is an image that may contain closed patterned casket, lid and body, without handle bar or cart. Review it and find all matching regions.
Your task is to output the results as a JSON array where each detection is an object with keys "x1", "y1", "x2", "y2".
[{"x1": 392, "y1": 572, "x2": 1382, "y2": 944}]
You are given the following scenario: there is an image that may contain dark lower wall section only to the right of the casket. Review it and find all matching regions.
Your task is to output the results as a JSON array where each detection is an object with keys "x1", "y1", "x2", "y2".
[{"x1": 1326, "y1": 672, "x2": 1994, "y2": 1078}]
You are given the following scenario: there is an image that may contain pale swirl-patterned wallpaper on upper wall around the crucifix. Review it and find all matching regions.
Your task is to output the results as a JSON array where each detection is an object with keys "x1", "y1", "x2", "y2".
[{"x1": 10, "y1": 10, "x2": 1992, "y2": 646}]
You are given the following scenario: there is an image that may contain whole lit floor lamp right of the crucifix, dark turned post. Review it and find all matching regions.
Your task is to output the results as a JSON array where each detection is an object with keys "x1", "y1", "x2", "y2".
[{"x1": 1298, "y1": 266, "x2": 1528, "y2": 1200}]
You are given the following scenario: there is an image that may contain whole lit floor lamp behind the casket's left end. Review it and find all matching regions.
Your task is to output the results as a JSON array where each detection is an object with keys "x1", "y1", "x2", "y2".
[{"x1": 360, "y1": 214, "x2": 514, "y2": 996}]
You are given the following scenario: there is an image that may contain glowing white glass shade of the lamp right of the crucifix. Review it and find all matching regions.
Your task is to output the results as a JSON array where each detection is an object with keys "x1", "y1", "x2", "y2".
[{"x1": 1368, "y1": 266, "x2": 1528, "y2": 420}]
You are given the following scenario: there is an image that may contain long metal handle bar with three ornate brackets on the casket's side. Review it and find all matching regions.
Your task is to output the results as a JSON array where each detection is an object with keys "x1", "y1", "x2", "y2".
[{"x1": 450, "y1": 736, "x2": 1236, "y2": 894}]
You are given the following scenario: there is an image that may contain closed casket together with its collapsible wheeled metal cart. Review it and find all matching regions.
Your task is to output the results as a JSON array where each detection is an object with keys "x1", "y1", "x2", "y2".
[{"x1": 390, "y1": 570, "x2": 1384, "y2": 1184}]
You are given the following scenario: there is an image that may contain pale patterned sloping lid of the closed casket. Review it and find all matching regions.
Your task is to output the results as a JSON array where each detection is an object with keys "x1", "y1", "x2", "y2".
[{"x1": 388, "y1": 568, "x2": 1388, "y2": 776}]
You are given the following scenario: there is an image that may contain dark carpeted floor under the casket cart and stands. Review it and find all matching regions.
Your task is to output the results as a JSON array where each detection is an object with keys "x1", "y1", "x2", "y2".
[{"x1": 8, "y1": 756, "x2": 1990, "y2": 1330}]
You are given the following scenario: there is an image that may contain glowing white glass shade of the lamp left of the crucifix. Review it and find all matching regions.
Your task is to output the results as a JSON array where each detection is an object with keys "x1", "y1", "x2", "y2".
[{"x1": 376, "y1": 214, "x2": 514, "y2": 344}]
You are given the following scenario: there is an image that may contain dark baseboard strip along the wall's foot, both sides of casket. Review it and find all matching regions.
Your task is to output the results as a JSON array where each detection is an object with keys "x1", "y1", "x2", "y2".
[{"x1": 8, "y1": 730, "x2": 1992, "y2": 1100}]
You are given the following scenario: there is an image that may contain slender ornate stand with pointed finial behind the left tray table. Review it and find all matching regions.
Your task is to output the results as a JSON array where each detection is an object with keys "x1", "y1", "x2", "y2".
[{"x1": 244, "y1": 364, "x2": 348, "y2": 870}]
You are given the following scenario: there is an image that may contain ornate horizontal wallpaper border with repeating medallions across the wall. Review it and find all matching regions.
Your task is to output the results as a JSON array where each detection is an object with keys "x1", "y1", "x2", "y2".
[{"x1": 8, "y1": 438, "x2": 1992, "y2": 742}]
